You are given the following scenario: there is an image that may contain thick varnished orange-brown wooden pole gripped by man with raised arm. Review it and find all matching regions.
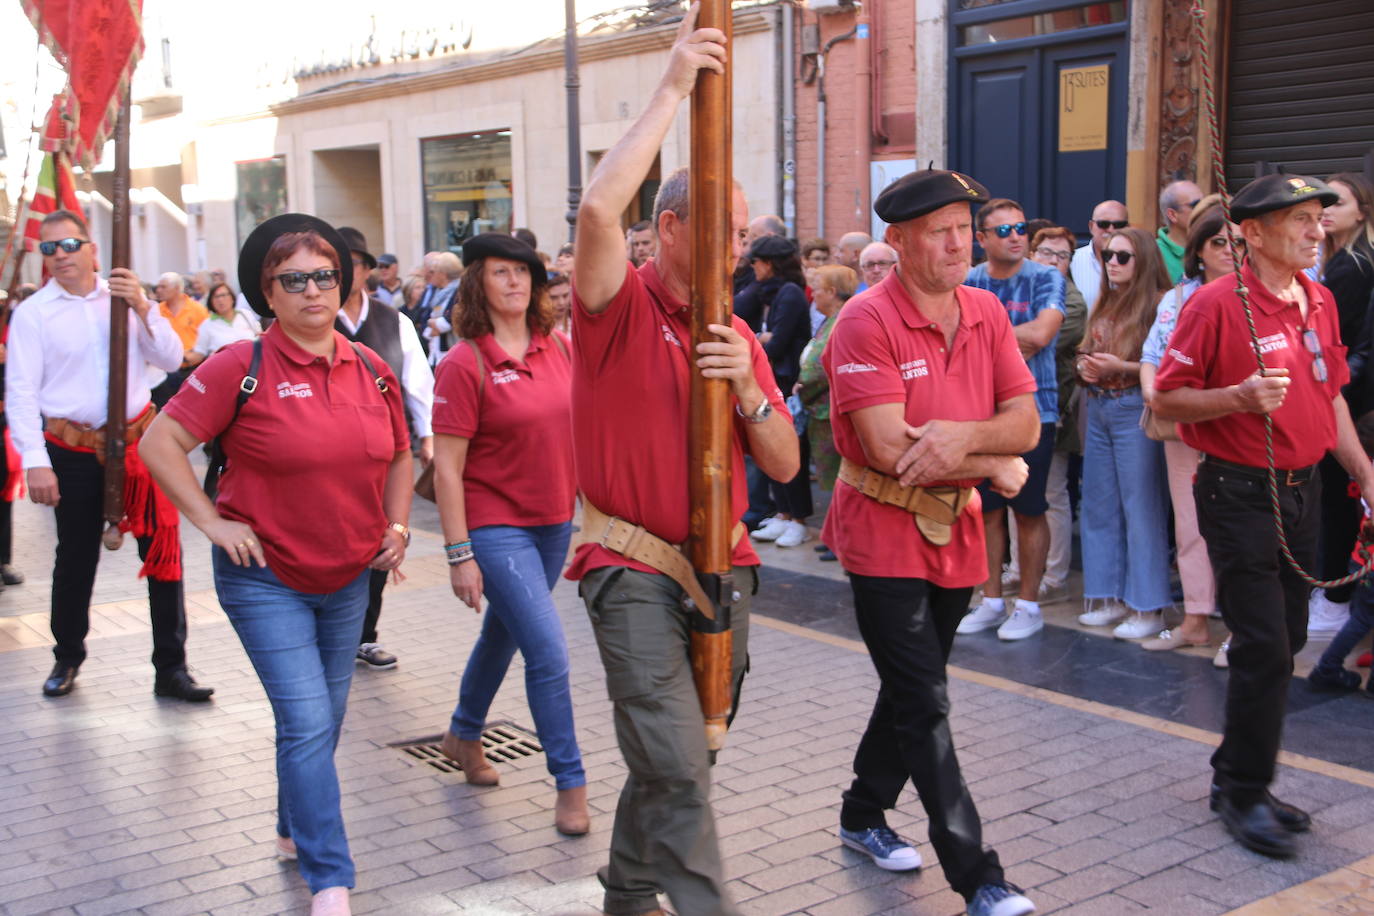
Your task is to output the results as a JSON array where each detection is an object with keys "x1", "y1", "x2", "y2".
[{"x1": 687, "y1": 0, "x2": 735, "y2": 750}]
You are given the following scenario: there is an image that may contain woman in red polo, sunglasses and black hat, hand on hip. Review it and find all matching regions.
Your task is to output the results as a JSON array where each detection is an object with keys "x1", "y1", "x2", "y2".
[{"x1": 139, "y1": 213, "x2": 411, "y2": 915}]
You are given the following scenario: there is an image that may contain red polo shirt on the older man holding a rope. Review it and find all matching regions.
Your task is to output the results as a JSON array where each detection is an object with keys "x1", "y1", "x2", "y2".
[{"x1": 1154, "y1": 264, "x2": 1351, "y2": 471}]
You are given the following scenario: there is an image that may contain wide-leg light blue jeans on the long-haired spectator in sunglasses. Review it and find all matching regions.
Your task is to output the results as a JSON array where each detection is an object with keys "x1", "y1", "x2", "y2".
[{"x1": 1079, "y1": 389, "x2": 1171, "y2": 611}]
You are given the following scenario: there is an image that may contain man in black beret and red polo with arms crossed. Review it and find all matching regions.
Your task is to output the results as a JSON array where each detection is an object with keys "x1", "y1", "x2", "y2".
[{"x1": 822, "y1": 169, "x2": 1040, "y2": 916}]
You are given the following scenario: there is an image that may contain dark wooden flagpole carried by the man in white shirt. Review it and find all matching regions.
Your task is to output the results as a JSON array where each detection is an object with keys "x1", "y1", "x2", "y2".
[{"x1": 104, "y1": 89, "x2": 132, "y2": 530}]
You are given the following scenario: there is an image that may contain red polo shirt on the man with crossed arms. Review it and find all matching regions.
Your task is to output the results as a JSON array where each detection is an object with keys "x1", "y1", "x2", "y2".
[{"x1": 820, "y1": 271, "x2": 1036, "y2": 588}]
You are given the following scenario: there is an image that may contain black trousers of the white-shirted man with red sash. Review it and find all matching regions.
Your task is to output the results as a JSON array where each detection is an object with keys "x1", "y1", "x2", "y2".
[{"x1": 48, "y1": 442, "x2": 185, "y2": 674}]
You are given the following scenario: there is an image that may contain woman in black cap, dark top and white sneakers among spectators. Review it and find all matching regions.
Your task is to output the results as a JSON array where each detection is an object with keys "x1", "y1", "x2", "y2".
[{"x1": 745, "y1": 235, "x2": 812, "y2": 547}]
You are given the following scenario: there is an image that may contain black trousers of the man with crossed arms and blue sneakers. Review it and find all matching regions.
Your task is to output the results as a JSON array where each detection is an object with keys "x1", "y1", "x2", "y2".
[{"x1": 840, "y1": 574, "x2": 1002, "y2": 900}]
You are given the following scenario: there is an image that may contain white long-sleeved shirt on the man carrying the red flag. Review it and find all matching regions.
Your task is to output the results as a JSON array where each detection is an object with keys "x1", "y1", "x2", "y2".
[{"x1": 4, "y1": 277, "x2": 183, "y2": 470}]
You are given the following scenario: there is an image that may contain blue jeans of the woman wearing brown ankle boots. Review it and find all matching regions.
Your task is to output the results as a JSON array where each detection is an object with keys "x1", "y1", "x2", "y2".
[{"x1": 449, "y1": 522, "x2": 587, "y2": 790}]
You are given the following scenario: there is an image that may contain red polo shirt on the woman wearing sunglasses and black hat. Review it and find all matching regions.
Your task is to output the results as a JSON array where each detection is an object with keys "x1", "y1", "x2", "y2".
[{"x1": 166, "y1": 324, "x2": 411, "y2": 595}]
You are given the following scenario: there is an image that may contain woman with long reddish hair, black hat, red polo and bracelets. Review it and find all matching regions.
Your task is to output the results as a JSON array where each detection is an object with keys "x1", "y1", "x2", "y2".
[{"x1": 434, "y1": 233, "x2": 589, "y2": 835}]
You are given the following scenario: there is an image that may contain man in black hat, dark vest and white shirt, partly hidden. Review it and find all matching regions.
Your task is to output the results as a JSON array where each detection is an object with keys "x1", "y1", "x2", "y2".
[{"x1": 334, "y1": 225, "x2": 434, "y2": 667}]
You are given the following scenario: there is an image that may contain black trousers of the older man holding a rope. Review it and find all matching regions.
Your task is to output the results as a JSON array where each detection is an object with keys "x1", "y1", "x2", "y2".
[{"x1": 1193, "y1": 461, "x2": 1322, "y2": 803}]
